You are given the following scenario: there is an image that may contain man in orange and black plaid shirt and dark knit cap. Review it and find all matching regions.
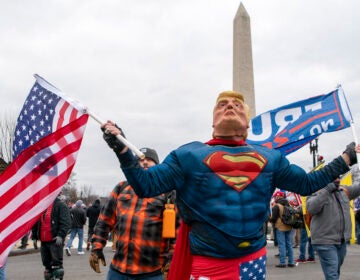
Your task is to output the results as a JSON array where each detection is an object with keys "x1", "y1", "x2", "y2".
[{"x1": 90, "y1": 148, "x2": 175, "y2": 280}]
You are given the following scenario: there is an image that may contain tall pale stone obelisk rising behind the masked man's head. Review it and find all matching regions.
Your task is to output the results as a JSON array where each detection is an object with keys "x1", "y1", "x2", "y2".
[{"x1": 233, "y1": 3, "x2": 256, "y2": 118}]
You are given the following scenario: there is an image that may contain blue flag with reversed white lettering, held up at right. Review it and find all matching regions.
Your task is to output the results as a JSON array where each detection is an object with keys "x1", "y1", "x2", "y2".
[{"x1": 246, "y1": 88, "x2": 352, "y2": 155}]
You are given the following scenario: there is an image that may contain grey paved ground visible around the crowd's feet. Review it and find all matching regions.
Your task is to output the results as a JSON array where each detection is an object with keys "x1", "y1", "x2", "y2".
[{"x1": 6, "y1": 238, "x2": 360, "y2": 280}]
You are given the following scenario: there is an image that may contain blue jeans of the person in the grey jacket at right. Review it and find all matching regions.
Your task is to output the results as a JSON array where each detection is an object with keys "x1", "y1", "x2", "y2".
[{"x1": 313, "y1": 243, "x2": 346, "y2": 280}]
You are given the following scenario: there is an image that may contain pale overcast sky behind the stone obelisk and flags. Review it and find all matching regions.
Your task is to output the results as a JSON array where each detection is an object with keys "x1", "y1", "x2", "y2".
[{"x1": 0, "y1": 0, "x2": 360, "y2": 195}]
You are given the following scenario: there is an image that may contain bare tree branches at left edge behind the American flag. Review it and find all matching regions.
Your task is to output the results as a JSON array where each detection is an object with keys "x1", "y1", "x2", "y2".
[{"x1": 0, "y1": 113, "x2": 16, "y2": 163}]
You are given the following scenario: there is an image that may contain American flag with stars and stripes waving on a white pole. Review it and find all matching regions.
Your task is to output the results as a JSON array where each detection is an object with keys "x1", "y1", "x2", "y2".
[{"x1": 0, "y1": 75, "x2": 88, "y2": 267}]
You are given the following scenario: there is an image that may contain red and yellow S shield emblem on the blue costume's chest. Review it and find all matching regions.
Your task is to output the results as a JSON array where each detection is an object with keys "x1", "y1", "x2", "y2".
[{"x1": 204, "y1": 151, "x2": 267, "y2": 192}]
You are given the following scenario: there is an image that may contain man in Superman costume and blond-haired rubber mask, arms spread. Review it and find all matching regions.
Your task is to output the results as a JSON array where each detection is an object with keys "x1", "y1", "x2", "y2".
[{"x1": 96, "y1": 91, "x2": 360, "y2": 280}]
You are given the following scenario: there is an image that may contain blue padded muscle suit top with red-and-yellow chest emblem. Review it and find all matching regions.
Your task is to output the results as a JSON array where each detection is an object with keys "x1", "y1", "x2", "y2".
[{"x1": 117, "y1": 141, "x2": 349, "y2": 258}]
